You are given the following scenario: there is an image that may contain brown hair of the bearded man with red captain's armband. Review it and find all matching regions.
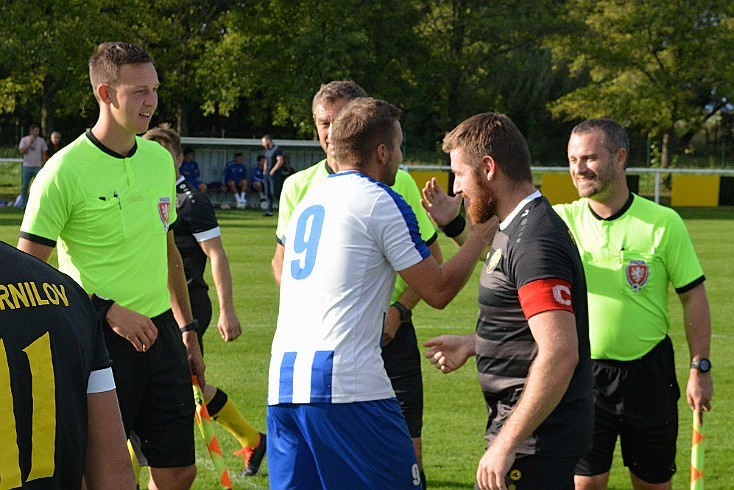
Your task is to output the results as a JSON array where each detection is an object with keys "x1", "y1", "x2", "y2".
[{"x1": 443, "y1": 112, "x2": 533, "y2": 182}]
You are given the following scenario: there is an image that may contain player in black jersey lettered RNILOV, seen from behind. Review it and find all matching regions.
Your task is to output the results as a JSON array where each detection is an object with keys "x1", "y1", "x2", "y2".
[{"x1": 0, "y1": 242, "x2": 135, "y2": 490}]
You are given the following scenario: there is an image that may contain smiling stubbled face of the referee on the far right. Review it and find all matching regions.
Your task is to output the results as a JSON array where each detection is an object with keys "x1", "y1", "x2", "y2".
[{"x1": 568, "y1": 131, "x2": 626, "y2": 202}]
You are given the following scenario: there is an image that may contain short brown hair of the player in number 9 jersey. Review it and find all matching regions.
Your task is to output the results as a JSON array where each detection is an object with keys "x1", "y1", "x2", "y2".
[{"x1": 331, "y1": 97, "x2": 401, "y2": 167}]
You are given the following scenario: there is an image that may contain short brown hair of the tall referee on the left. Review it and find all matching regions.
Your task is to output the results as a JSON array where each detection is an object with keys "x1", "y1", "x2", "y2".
[{"x1": 89, "y1": 42, "x2": 153, "y2": 97}]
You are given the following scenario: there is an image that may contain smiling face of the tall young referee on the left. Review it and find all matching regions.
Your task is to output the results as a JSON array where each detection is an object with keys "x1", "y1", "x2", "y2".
[{"x1": 105, "y1": 63, "x2": 159, "y2": 134}]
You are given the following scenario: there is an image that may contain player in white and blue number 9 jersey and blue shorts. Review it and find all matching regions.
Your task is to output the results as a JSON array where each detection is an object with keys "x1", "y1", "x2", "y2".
[{"x1": 267, "y1": 98, "x2": 491, "y2": 489}]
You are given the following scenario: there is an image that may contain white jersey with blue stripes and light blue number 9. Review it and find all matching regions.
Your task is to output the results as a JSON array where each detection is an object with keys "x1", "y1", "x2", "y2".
[{"x1": 268, "y1": 172, "x2": 431, "y2": 405}]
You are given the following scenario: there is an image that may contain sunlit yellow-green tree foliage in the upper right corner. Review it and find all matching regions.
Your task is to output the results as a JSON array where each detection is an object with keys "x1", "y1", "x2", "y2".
[{"x1": 547, "y1": 0, "x2": 734, "y2": 148}]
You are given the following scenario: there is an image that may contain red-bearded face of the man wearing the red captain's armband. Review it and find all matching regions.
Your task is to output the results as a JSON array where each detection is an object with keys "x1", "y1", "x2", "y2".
[{"x1": 449, "y1": 148, "x2": 497, "y2": 223}]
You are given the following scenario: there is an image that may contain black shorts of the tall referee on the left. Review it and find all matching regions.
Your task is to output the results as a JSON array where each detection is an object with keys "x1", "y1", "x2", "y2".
[{"x1": 104, "y1": 310, "x2": 194, "y2": 468}]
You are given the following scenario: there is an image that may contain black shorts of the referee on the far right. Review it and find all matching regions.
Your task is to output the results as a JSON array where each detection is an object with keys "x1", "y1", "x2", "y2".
[{"x1": 576, "y1": 337, "x2": 680, "y2": 483}]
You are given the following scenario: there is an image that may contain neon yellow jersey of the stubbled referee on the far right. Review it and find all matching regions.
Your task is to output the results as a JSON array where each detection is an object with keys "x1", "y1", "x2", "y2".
[{"x1": 553, "y1": 195, "x2": 705, "y2": 361}]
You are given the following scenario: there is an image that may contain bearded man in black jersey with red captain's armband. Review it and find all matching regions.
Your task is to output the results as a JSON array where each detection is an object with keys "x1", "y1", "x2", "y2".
[{"x1": 423, "y1": 113, "x2": 593, "y2": 490}]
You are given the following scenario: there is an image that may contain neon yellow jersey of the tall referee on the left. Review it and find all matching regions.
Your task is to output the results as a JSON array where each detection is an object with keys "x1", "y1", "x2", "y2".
[{"x1": 20, "y1": 131, "x2": 176, "y2": 317}]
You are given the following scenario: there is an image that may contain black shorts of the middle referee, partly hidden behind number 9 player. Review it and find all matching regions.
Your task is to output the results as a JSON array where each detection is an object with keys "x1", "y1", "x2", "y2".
[{"x1": 382, "y1": 322, "x2": 423, "y2": 437}]
